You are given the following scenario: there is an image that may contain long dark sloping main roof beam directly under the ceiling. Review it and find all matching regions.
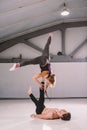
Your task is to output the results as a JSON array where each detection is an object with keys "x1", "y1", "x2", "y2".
[{"x1": 0, "y1": 21, "x2": 87, "y2": 44}]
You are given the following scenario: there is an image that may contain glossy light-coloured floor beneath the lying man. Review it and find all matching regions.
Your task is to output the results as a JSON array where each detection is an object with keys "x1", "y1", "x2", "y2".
[{"x1": 0, "y1": 99, "x2": 87, "y2": 130}]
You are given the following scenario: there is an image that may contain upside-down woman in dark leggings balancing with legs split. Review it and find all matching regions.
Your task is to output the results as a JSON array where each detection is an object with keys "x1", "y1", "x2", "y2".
[{"x1": 10, "y1": 35, "x2": 55, "y2": 92}]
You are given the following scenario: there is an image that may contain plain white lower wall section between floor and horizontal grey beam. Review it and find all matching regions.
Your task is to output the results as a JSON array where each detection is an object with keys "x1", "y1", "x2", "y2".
[{"x1": 0, "y1": 63, "x2": 87, "y2": 98}]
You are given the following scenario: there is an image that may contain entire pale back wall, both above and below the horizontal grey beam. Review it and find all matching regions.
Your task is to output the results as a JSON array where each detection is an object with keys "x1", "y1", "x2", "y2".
[{"x1": 0, "y1": 27, "x2": 87, "y2": 98}]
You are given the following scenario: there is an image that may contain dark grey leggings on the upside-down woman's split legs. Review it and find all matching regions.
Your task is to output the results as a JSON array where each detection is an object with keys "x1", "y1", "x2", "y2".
[{"x1": 20, "y1": 36, "x2": 51, "y2": 67}]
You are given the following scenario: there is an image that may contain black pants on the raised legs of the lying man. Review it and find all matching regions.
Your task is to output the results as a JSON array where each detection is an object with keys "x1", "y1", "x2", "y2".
[{"x1": 29, "y1": 89, "x2": 45, "y2": 114}]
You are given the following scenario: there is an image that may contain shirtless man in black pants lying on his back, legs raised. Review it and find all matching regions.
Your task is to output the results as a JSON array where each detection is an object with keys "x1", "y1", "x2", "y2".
[{"x1": 28, "y1": 82, "x2": 71, "y2": 121}]
